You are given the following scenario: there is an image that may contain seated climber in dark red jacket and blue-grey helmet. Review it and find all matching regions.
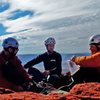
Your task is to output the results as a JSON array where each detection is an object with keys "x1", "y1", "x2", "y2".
[{"x1": 0, "y1": 38, "x2": 32, "y2": 91}]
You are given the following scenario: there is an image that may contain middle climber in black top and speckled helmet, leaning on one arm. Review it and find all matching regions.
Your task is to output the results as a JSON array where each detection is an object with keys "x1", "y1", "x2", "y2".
[{"x1": 24, "y1": 37, "x2": 62, "y2": 83}]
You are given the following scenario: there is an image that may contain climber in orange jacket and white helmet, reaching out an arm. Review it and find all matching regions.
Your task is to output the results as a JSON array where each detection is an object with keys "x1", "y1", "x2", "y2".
[{"x1": 70, "y1": 34, "x2": 100, "y2": 82}]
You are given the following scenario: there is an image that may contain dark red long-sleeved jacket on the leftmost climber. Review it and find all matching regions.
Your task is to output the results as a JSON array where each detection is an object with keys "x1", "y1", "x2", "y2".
[{"x1": 0, "y1": 52, "x2": 30, "y2": 89}]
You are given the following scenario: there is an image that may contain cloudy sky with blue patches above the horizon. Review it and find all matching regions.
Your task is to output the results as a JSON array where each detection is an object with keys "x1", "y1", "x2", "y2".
[{"x1": 0, "y1": 0, "x2": 100, "y2": 54}]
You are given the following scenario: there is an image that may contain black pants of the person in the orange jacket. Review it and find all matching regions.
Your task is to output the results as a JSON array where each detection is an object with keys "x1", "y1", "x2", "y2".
[{"x1": 73, "y1": 68, "x2": 100, "y2": 84}]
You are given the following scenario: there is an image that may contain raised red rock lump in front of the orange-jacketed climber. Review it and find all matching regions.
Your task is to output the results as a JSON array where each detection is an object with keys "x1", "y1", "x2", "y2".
[{"x1": 70, "y1": 83, "x2": 100, "y2": 100}]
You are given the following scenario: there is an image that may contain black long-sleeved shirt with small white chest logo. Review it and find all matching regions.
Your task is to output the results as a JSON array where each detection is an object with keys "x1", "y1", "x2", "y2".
[{"x1": 24, "y1": 51, "x2": 62, "y2": 74}]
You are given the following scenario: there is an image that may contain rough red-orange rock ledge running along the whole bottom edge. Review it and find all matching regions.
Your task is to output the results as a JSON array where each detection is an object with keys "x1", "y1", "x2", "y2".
[{"x1": 0, "y1": 83, "x2": 100, "y2": 100}]
